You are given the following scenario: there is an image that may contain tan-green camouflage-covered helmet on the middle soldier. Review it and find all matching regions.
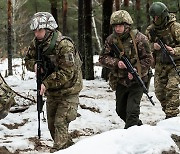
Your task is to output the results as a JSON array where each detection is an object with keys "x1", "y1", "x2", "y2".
[{"x1": 110, "y1": 10, "x2": 133, "y2": 25}]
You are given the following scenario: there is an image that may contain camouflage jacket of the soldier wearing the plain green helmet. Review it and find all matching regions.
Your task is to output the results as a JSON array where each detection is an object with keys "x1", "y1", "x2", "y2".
[{"x1": 145, "y1": 14, "x2": 180, "y2": 65}]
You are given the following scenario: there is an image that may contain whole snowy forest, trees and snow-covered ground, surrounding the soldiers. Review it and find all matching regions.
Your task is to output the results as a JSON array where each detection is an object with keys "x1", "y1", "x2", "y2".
[{"x1": 0, "y1": 0, "x2": 180, "y2": 154}]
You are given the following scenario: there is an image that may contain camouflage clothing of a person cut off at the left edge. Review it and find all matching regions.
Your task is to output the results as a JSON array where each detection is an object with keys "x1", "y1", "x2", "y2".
[{"x1": 0, "y1": 75, "x2": 15, "y2": 119}]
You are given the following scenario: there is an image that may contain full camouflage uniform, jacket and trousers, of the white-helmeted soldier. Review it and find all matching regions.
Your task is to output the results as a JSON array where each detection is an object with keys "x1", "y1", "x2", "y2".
[{"x1": 25, "y1": 11, "x2": 82, "y2": 152}]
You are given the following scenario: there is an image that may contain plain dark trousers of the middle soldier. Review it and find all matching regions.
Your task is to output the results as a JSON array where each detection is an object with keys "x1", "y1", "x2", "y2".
[{"x1": 116, "y1": 83, "x2": 143, "y2": 129}]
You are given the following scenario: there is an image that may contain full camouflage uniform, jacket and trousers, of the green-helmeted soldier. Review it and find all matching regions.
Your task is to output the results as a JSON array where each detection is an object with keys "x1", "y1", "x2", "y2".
[{"x1": 146, "y1": 14, "x2": 180, "y2": 117}]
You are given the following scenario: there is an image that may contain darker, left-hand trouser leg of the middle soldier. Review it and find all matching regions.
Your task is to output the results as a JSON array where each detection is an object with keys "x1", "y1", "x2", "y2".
[{"x1": 116, "y1": 84, "x2": 128, "y2": 123}]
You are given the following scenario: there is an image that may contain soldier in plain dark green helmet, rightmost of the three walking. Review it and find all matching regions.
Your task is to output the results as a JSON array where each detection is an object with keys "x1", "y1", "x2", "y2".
[{"x1": 146, "y1": 2, "x2": 180, "y2": 118}]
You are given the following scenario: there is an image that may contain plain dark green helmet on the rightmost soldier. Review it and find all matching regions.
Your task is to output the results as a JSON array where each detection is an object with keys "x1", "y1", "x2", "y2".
[{"x1": 149, "y1": 2, "x2": 169, "y2": 25}]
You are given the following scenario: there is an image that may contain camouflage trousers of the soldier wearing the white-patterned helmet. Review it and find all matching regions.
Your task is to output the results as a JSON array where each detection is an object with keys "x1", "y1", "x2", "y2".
[{"x1": 46, "y1": 94, "x2": 79, "y2": 151}]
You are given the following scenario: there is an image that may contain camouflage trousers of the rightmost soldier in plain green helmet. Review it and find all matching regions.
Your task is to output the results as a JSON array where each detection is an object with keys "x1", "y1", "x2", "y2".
[{"x1": 154, "y1": 65, "x2": 180, "y2": 118}]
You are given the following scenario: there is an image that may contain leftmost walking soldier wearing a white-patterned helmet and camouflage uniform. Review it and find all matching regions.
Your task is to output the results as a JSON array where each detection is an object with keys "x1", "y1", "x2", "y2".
[{"x1": 25, "y1": 12, "x2": 82, "y2": 152}]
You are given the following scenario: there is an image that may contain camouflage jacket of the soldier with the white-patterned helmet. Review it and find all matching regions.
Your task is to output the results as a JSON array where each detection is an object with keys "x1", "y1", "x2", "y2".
[{"x1": 25, "y1": 31, "x2": 82, "y2": 96}]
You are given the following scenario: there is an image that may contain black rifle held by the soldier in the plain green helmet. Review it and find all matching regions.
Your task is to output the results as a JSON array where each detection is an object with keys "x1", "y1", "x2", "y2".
[{"x1": 150, "y1": 30, "x2": 180, "y2": 76}]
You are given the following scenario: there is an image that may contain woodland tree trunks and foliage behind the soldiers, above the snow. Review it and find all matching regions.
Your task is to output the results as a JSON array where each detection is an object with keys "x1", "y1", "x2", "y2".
[{"x1": 0, "y1": 0, "x2": 180, "y2": 80}]
